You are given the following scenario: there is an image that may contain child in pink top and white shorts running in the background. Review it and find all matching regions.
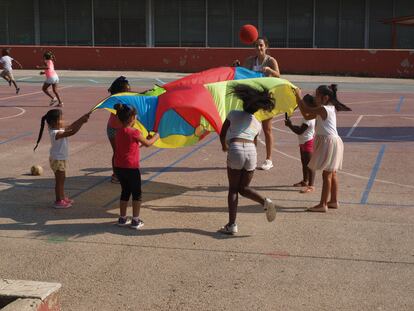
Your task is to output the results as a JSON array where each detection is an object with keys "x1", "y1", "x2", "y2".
[{"x1": 36, "y1": 51, "x2": 63, "y2": 107}]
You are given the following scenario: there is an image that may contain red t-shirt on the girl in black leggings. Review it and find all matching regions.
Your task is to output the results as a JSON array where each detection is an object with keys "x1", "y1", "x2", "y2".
[{"x1": 114, "y1": 127, "x2": 141, "y2": 168}]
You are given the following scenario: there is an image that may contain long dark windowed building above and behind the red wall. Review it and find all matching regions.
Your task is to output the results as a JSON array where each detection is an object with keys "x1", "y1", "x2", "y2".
[{"x1": 0, "y1": 0, "x2": 414, "y2": 49}]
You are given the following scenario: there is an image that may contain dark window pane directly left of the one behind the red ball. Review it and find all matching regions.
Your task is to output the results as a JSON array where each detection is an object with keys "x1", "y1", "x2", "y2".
[{"x1": 207, "y1": 0, "x2": 232, "y2": 47}]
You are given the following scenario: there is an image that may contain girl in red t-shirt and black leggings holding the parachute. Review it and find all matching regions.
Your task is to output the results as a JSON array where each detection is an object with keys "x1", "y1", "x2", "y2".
[{"x1": 114, "y1": 104, "x2": 159, "y2": 229}]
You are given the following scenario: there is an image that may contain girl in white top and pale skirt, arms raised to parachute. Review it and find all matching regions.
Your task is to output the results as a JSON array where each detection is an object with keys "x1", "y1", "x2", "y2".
[{"x1": 296, "y1": 84, "x2": 351, "y2": 213}]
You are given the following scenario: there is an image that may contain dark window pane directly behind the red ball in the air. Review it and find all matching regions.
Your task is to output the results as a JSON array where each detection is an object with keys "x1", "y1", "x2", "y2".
[{"x1": 233, "y1": 0, "x2": 259, "y2": 47}]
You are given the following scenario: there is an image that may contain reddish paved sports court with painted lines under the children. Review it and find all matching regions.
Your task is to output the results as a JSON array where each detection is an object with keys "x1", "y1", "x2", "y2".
[{"x1": 0, "y1": 70, "x2": 414, "y2": 311}]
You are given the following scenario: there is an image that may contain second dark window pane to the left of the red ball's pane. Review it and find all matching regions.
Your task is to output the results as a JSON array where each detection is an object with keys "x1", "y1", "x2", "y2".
[{"x1": 180, "y1": 0, "x2": 206, "y2": 46}]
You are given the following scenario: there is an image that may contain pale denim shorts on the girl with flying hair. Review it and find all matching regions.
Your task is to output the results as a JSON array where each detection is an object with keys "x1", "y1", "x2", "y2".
[{"x1": 227, "y1": 142, "x2": 257, "y2": 171}]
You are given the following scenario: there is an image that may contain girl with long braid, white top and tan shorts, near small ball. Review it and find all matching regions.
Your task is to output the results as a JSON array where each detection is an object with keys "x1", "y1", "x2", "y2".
[{"x1": 34, "y1": 109, "x2": 91, "y2": 208}]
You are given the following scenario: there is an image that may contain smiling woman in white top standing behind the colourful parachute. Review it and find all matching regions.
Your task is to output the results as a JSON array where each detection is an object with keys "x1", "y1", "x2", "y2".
[{"x1": 233, "y1": 37, "x2": 280, "y2": 170}]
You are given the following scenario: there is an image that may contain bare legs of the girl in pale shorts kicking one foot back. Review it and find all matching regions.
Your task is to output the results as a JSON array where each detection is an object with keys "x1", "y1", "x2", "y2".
[{"x1": 227, "y1": 167, "x2": 265, "y2": 225}]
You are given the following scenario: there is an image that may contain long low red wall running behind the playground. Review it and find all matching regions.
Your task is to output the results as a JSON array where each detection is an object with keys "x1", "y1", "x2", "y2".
[{"x1": 7, "y1": 46, "x2": 414, "y2": 78}]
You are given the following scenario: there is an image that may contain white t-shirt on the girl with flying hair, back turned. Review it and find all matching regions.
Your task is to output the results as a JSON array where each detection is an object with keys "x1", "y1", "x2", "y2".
[{"x1": 226, "y1": 110, "x2": 262, "y2": 141}]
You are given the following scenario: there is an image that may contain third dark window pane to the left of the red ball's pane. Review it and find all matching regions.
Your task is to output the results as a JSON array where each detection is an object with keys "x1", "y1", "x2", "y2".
[{"x1": 153, "y1": 0, "x2": 180, "y2": 46}]
